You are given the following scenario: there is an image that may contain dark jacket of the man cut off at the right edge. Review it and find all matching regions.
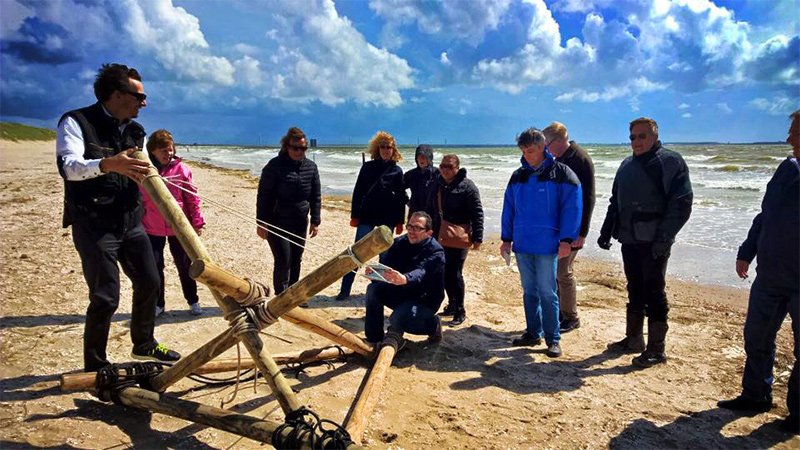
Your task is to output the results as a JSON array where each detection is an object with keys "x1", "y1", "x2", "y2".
[{"x1": 736, "y1": 158, "x2": 800, "y2": 292}]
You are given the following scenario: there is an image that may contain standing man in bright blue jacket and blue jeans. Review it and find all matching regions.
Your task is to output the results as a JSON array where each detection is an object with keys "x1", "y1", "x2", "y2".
[{"x1": 500, "y1": 128, "x2": 582, "y2": 358}]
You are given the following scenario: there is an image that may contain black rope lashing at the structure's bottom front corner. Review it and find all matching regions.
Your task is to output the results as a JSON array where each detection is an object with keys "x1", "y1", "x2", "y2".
[{"x1": 272, "y1": 406, "x2": 353, "y2": 450}]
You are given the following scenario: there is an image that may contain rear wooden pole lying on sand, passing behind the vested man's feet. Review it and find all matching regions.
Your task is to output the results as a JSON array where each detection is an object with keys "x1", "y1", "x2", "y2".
[{"x1": 61, "y1": 347, "x2": 353, "y2": 392}]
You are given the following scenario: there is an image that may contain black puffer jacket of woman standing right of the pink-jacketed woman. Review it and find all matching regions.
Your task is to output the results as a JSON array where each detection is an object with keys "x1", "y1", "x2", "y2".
[{"x1": 256, "y1": 151, "x2": 321, "y2": 225}]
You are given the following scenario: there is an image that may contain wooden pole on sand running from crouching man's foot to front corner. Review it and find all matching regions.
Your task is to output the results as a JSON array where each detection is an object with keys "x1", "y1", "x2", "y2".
[{"x1": 344, "y1": 333, "x2": 403, "y2": 444}]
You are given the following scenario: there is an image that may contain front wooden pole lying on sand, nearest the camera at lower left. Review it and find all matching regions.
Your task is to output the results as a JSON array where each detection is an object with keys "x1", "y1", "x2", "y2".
[{"x1": 114, "y1": 387, "x2": 361, "y2": 450}]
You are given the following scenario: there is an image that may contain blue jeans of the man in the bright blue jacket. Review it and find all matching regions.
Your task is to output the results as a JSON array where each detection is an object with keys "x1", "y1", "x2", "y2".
[{"x1": 515, "y1": 253, "x2": 561, "y2": 345}]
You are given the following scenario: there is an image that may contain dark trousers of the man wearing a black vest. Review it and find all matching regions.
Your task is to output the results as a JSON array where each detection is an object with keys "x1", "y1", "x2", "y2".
[{"x1": 72, "y1": 223, "x2": 159, "y2": 371}]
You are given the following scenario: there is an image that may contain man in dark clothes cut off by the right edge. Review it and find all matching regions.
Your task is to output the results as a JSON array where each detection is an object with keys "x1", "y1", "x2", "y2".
[{"x1": 718, "y1": 110, "x2": 800, "y2": 434}]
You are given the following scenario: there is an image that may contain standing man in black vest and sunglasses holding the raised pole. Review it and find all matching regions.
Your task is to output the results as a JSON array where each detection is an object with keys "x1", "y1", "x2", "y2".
[{"x1": 56, "y1": 64, "x2": 180, "y2": 372}]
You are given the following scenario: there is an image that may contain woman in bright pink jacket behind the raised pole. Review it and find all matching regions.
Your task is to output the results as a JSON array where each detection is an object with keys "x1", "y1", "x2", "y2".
[{"x1": 139, "y1": 130, "x2": 205, "y2": 316}]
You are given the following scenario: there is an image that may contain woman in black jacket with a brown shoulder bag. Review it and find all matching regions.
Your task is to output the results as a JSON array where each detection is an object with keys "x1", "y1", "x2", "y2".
[{"x1": 434, "y1": 155, "x2": 483, "y2": 326}]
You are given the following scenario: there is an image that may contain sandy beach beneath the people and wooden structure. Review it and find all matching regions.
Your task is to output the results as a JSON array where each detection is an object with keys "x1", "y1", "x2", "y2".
[{"x1": 0, "y1": 141, "x2": 800, "y2": 449}]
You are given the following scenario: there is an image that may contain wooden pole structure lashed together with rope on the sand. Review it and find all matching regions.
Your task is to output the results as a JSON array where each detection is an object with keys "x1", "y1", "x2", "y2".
[{"x1": 62, "y1": 152, "x2": 404, "y2": 448}]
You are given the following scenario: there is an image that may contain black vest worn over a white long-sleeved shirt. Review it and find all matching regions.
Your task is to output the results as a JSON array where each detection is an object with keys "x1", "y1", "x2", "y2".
[{"x1": 56, "y1": 103, "x2": 145, "y2": 230}]
